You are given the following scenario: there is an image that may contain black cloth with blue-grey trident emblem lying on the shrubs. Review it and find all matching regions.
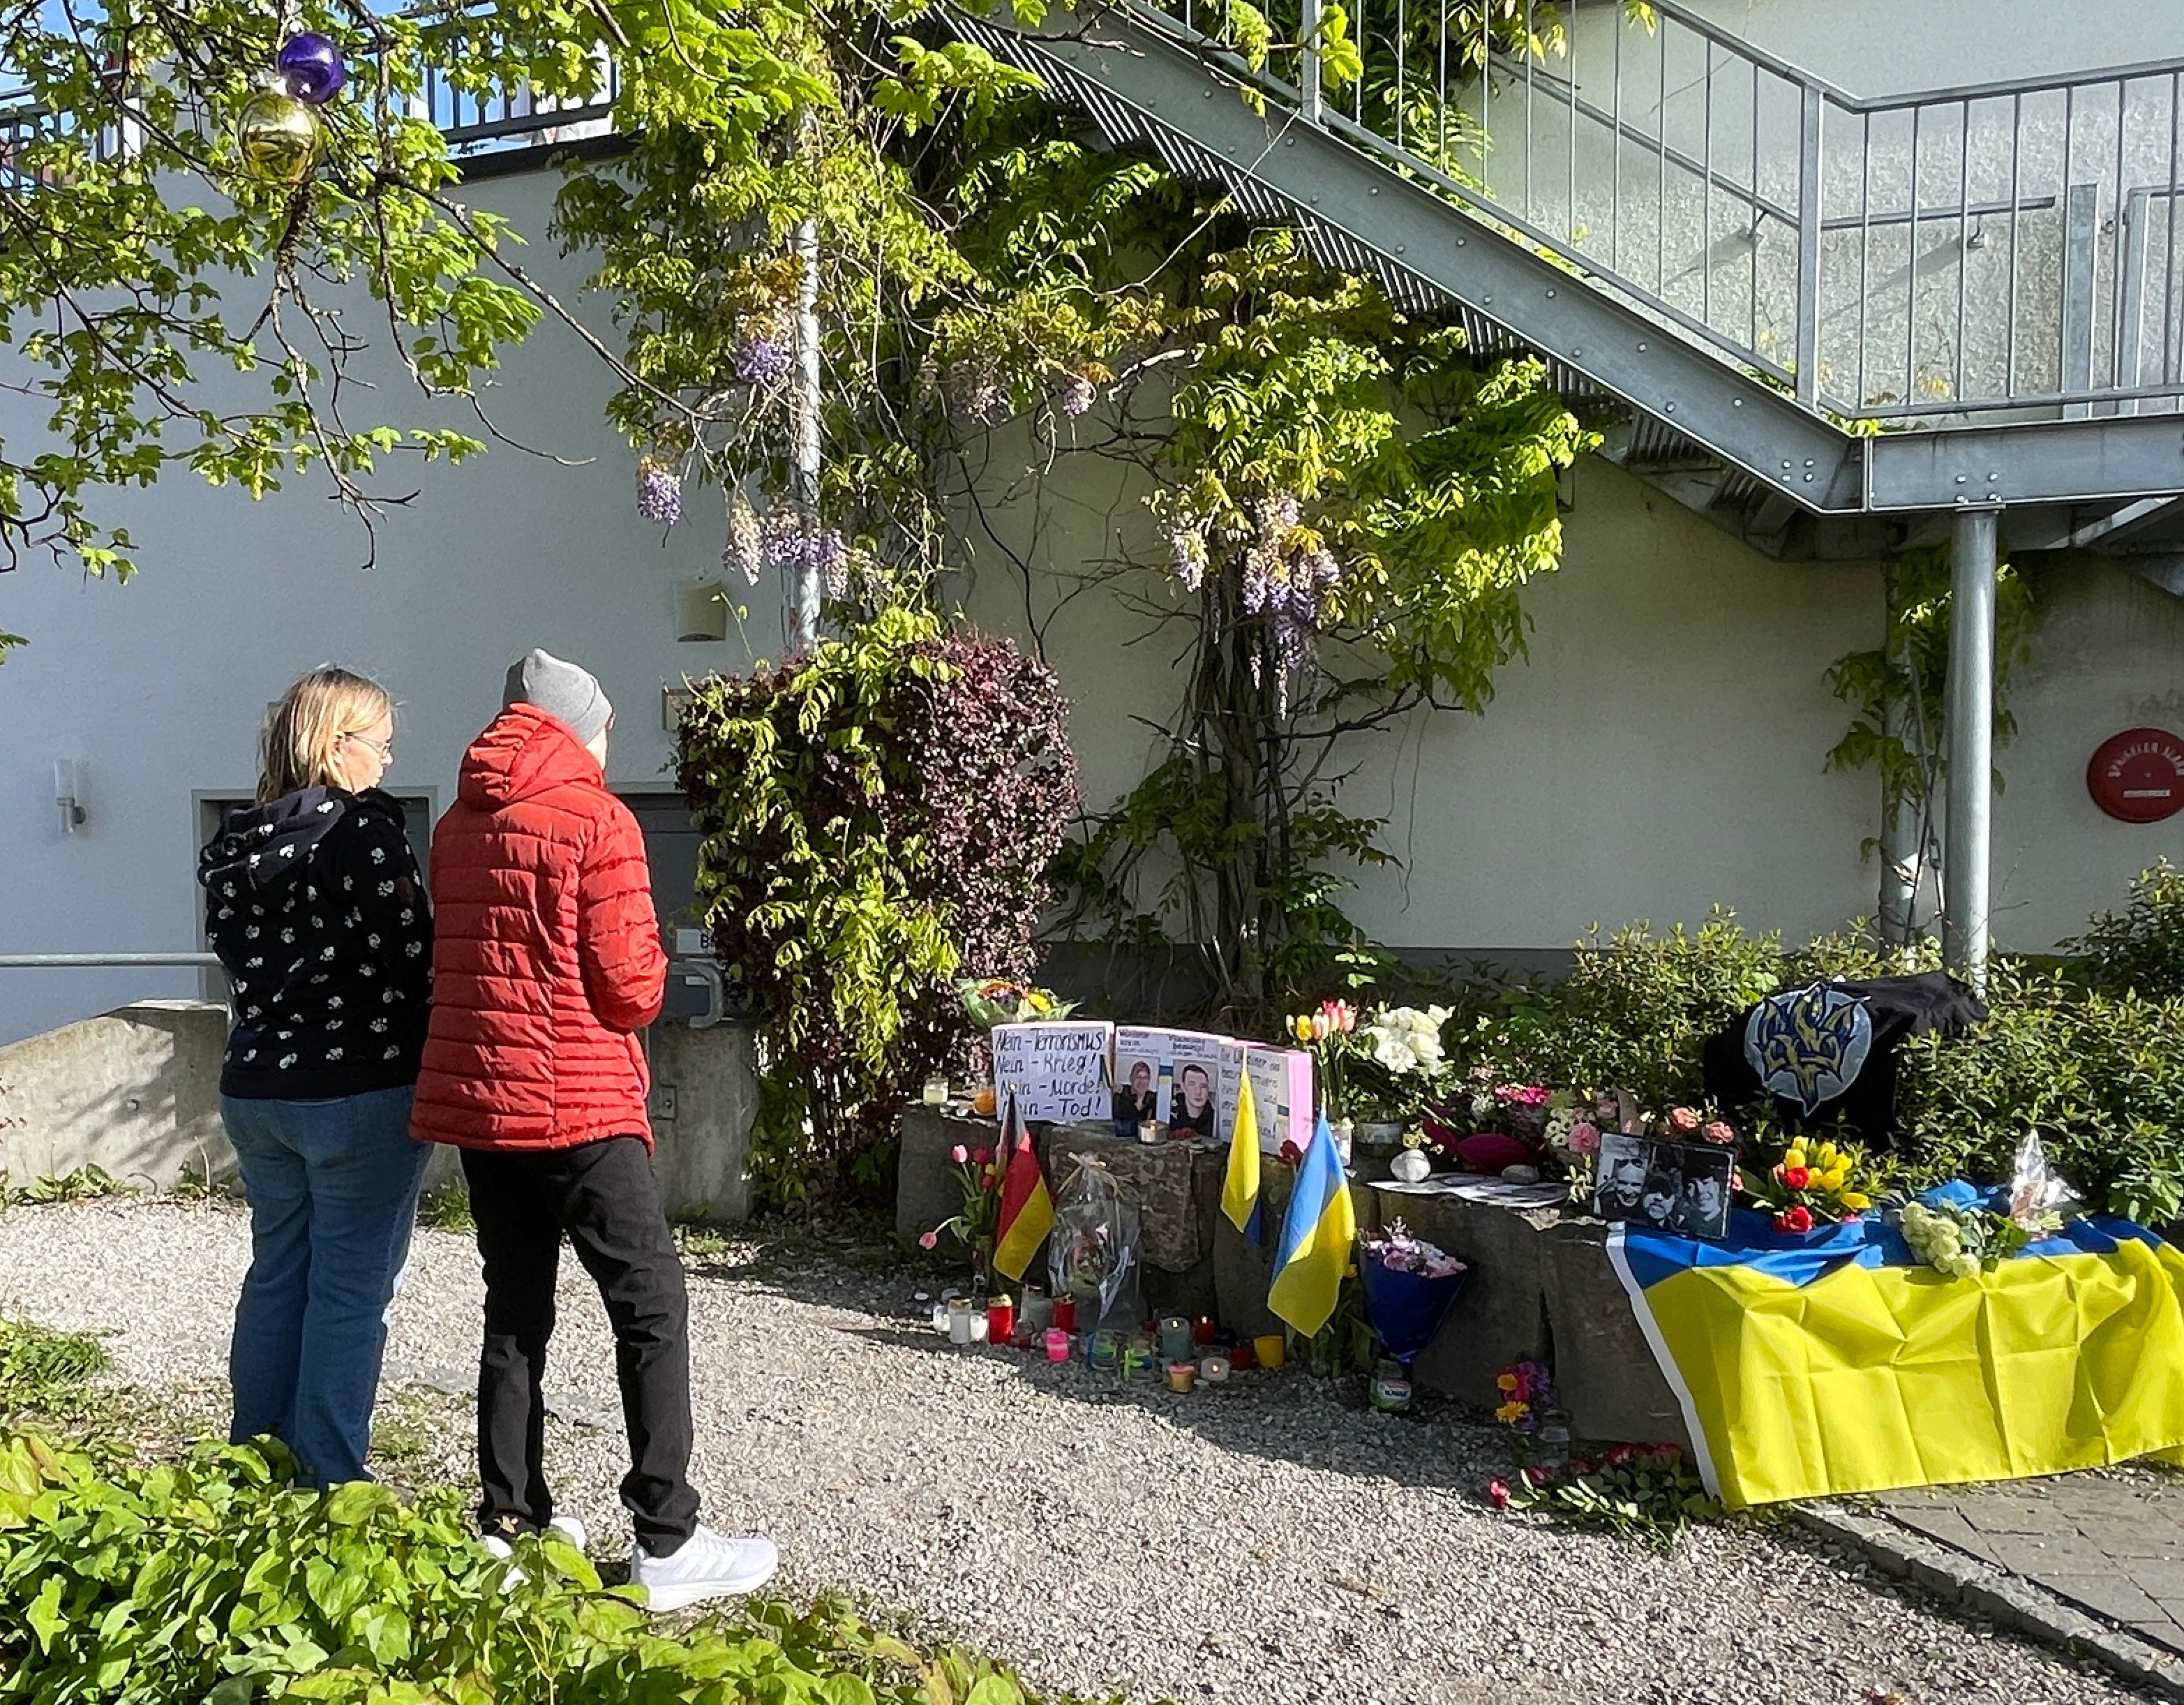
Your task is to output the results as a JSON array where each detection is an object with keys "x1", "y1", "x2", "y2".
[{"x1": 1706, "y1": 971, "x2": 1987, "y2": 1150}]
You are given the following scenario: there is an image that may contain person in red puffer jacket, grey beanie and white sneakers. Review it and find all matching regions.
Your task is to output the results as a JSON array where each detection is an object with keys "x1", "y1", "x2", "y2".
[{"x1": 410, "y1": 650, "x2": 779, "y2": 1611}]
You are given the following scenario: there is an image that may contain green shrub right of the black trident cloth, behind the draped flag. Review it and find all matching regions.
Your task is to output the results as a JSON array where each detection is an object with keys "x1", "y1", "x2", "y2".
[{"x1": 1896, "y1": 960, "x2": 2184, "y2": 1227}]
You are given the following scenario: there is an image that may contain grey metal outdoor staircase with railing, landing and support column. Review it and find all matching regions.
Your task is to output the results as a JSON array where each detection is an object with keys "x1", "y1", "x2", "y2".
[{"x1": 955, "y1": 0, "x2": 2184, "y2": 976}]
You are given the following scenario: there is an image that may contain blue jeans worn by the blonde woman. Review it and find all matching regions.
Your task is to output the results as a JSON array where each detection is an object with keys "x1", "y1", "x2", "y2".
[{"x1": 220, "y1": 1085, "x2": 433, "y2": 1487}]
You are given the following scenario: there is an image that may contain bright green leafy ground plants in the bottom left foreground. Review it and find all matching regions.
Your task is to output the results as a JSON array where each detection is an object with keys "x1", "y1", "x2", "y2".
[{"x1": 0, "y1": 1434, "x2": 1048, "y2": 1705}]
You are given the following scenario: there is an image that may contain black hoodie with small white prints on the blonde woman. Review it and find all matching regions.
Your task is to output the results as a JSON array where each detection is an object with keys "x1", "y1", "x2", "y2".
[{"x1": 197, "y1": 788, "x2": 433, "y2": 1101}]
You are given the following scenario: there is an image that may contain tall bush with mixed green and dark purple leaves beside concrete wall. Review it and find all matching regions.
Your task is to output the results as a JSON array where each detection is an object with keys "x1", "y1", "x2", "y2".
[{"x1": 677, "y1": 609, "x2": 1079, "y2": 1207}]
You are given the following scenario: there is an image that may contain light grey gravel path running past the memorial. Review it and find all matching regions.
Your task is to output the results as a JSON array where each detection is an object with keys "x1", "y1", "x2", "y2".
[{"x1": 0, "y1": 1203, "x2": 2136, "y2": 1705}]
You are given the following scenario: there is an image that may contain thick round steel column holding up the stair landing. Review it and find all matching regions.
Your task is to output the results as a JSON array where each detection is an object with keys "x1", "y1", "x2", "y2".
[{"x1": 1942, "y1": 509, "x2": 2000, "y2": 989}]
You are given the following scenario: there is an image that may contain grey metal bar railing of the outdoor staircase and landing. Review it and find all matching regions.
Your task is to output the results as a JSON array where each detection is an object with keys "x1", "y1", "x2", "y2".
[{"x1": 1125, "y1": 0, "x2": 2184, "y2": 424}]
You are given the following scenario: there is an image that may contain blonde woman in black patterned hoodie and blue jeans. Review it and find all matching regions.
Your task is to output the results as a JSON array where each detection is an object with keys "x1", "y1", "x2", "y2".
[{"x1": 197, "y1": 668, "x2": 433, "y2": 1487}]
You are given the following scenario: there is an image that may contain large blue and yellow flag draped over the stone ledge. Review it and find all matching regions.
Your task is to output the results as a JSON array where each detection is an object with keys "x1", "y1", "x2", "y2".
[{"x1": 1608, "y1": 1183, "x2": 2184, "y2": 1508}]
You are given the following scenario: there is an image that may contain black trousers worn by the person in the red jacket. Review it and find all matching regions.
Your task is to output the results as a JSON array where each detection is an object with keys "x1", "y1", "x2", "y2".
[{"x1": 463, "y1": 1138, "x2": 696, "y2": 1556}]
